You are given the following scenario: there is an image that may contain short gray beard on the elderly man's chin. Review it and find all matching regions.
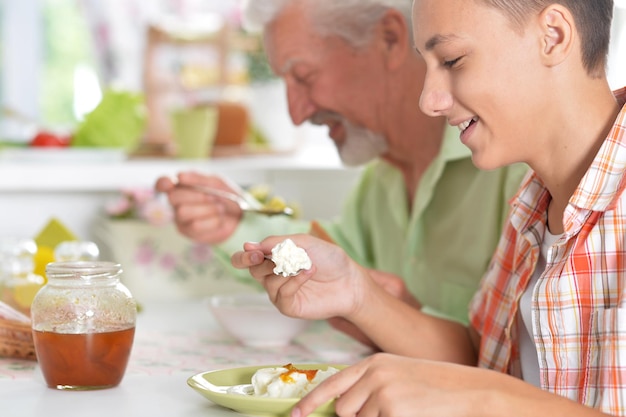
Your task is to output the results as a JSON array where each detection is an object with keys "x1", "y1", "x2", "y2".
[{"x1": 337, "y1": 119, "x2": 389, "y2": 166}]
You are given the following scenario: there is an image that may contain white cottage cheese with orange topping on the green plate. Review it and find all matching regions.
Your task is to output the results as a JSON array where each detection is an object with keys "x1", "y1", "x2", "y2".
[{"x1": 252, "y1": 364, "x2": 339, "y2": 398}]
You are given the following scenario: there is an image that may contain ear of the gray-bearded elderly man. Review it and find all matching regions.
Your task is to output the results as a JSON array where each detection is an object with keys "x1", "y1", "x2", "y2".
[{"x1": 375, "y1": 10, "x2": 413, "y2": 69}]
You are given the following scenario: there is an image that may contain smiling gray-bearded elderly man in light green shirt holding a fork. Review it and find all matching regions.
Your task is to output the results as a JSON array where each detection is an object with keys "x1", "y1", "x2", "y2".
[{"x1": 156, "y1": 0, "x2": 526, "y2": 338}]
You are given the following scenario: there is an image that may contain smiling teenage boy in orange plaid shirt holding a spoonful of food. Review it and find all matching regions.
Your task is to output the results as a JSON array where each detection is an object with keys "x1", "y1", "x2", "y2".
[{"x1": 232, "y1": 0, "x2": 626, "y2": 417}]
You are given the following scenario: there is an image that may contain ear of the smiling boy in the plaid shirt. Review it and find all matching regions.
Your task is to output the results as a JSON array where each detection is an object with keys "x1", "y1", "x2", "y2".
[{"x1": 539, "y1": 4, "x2": 576, "y2": 67}]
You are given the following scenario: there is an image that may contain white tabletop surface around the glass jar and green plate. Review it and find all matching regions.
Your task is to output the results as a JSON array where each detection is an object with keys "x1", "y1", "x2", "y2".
[{"x1": 0, "y1": 301, "x2": 369, "y2": 417}]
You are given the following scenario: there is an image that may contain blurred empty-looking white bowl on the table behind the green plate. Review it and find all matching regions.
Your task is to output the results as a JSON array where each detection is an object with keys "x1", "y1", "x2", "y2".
[{"x1": 208, "y1": 292, "x2": 310, "y2": 347}]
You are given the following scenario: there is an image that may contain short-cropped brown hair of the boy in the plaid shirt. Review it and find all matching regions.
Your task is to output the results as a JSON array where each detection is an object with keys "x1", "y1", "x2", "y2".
[{"x1": 479, "y1": 0, "x2": 613, "y2": 77}]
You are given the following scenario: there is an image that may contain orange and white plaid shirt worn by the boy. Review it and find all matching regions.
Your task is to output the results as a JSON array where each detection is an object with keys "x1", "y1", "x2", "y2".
[{"x1": 470, "y1": 88, "x2": 626, "y2": 415}]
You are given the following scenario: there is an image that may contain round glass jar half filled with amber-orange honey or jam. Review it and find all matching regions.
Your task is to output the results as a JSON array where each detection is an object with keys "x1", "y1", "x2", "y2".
[{"x1": 31, "y1": 261, "x2": 137, "y2": 390}]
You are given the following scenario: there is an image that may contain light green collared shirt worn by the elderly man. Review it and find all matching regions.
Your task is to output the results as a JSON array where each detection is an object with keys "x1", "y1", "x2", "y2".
[{"x1": 214, "y1": 129, "x2": 527, "y2": 323}]
